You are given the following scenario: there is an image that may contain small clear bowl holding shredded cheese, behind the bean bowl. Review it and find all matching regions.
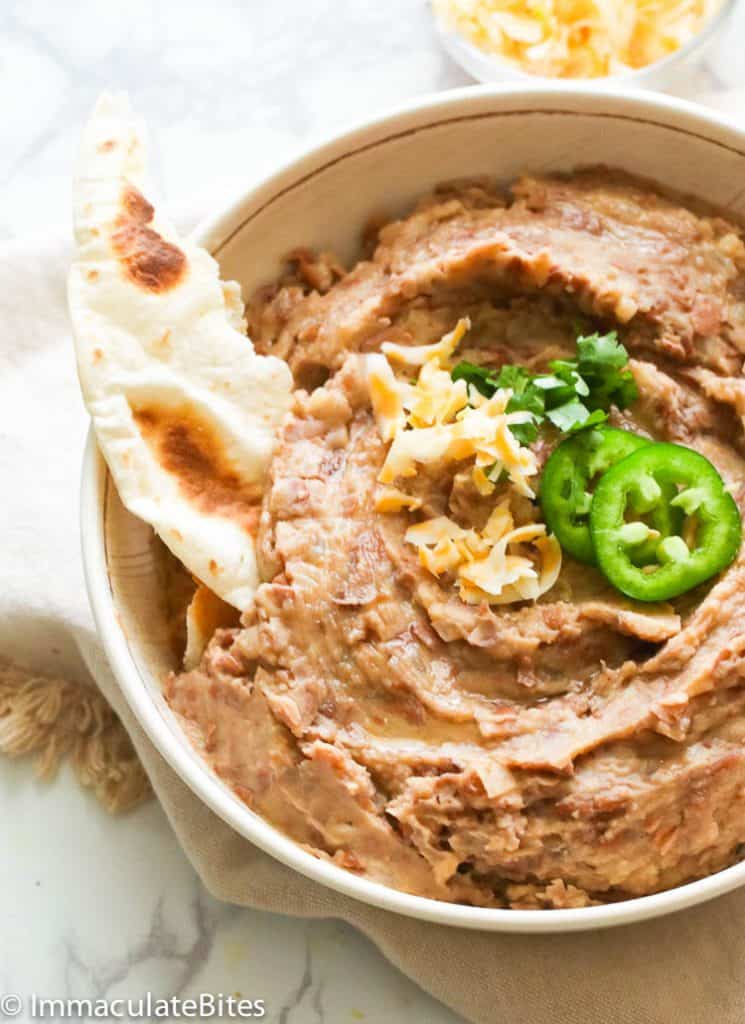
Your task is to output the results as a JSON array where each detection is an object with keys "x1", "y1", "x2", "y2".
[{"x1": 432, "y1": 0, "x2": 740, "y2": 91}]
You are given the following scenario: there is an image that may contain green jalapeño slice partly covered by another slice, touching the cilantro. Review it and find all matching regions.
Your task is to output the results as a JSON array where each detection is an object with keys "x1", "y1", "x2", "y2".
[{"x1": 539, "y1": 427, "x2": 652, "y2": 565}]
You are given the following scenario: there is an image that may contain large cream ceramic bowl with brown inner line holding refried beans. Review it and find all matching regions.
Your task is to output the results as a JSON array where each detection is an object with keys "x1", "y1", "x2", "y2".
[{"x1": 82, "y1": 87, "x2": 745, "y2": 932}]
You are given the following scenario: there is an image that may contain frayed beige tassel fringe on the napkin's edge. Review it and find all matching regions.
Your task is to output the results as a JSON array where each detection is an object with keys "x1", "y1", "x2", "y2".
[{"x1": 0, "y1": 662, "x2": 151, "y2": 814}]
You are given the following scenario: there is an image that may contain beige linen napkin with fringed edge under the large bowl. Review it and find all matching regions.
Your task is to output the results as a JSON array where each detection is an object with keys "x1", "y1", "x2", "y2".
[{"x1": 0, "y1": 96, "x2": 745, "y2": 1024}]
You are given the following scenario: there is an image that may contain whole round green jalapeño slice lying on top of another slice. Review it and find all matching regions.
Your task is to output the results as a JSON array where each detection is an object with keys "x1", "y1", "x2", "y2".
[{"x1": 589, "y1": 443, "x2": 742, "y2": 601}]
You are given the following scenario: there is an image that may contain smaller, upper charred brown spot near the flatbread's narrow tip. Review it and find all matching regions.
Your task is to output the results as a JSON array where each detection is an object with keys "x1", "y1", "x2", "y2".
[{"x1": 112, "y1": 184, "x2": 187, "y2": 292}]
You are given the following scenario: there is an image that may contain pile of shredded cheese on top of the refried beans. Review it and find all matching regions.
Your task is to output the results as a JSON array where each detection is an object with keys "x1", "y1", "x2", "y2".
[{"x1": 364, "y1": 318, "x2": 561, "y2": 604}]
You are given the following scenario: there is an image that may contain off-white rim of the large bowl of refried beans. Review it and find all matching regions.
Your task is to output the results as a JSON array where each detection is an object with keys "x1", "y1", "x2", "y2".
[{"x1": 80, "y1": 84, "x2": 745, "y2": 934}]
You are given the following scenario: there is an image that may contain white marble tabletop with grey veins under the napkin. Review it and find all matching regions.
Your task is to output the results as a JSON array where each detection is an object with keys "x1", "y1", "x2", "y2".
[{"x1": 0, "y1": 0, "x2": 745, "y2": 1024}]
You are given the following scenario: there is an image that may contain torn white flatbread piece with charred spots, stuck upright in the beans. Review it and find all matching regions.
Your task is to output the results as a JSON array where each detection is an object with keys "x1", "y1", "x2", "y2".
[{"x1": 69, "y1": 95, "x2": 292, "y2": 608}]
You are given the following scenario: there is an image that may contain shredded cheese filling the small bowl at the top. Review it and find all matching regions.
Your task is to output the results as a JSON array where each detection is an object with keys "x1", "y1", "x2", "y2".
[{"x1": 433, "y1": 0, "x2": 721, "y2": 78}]
